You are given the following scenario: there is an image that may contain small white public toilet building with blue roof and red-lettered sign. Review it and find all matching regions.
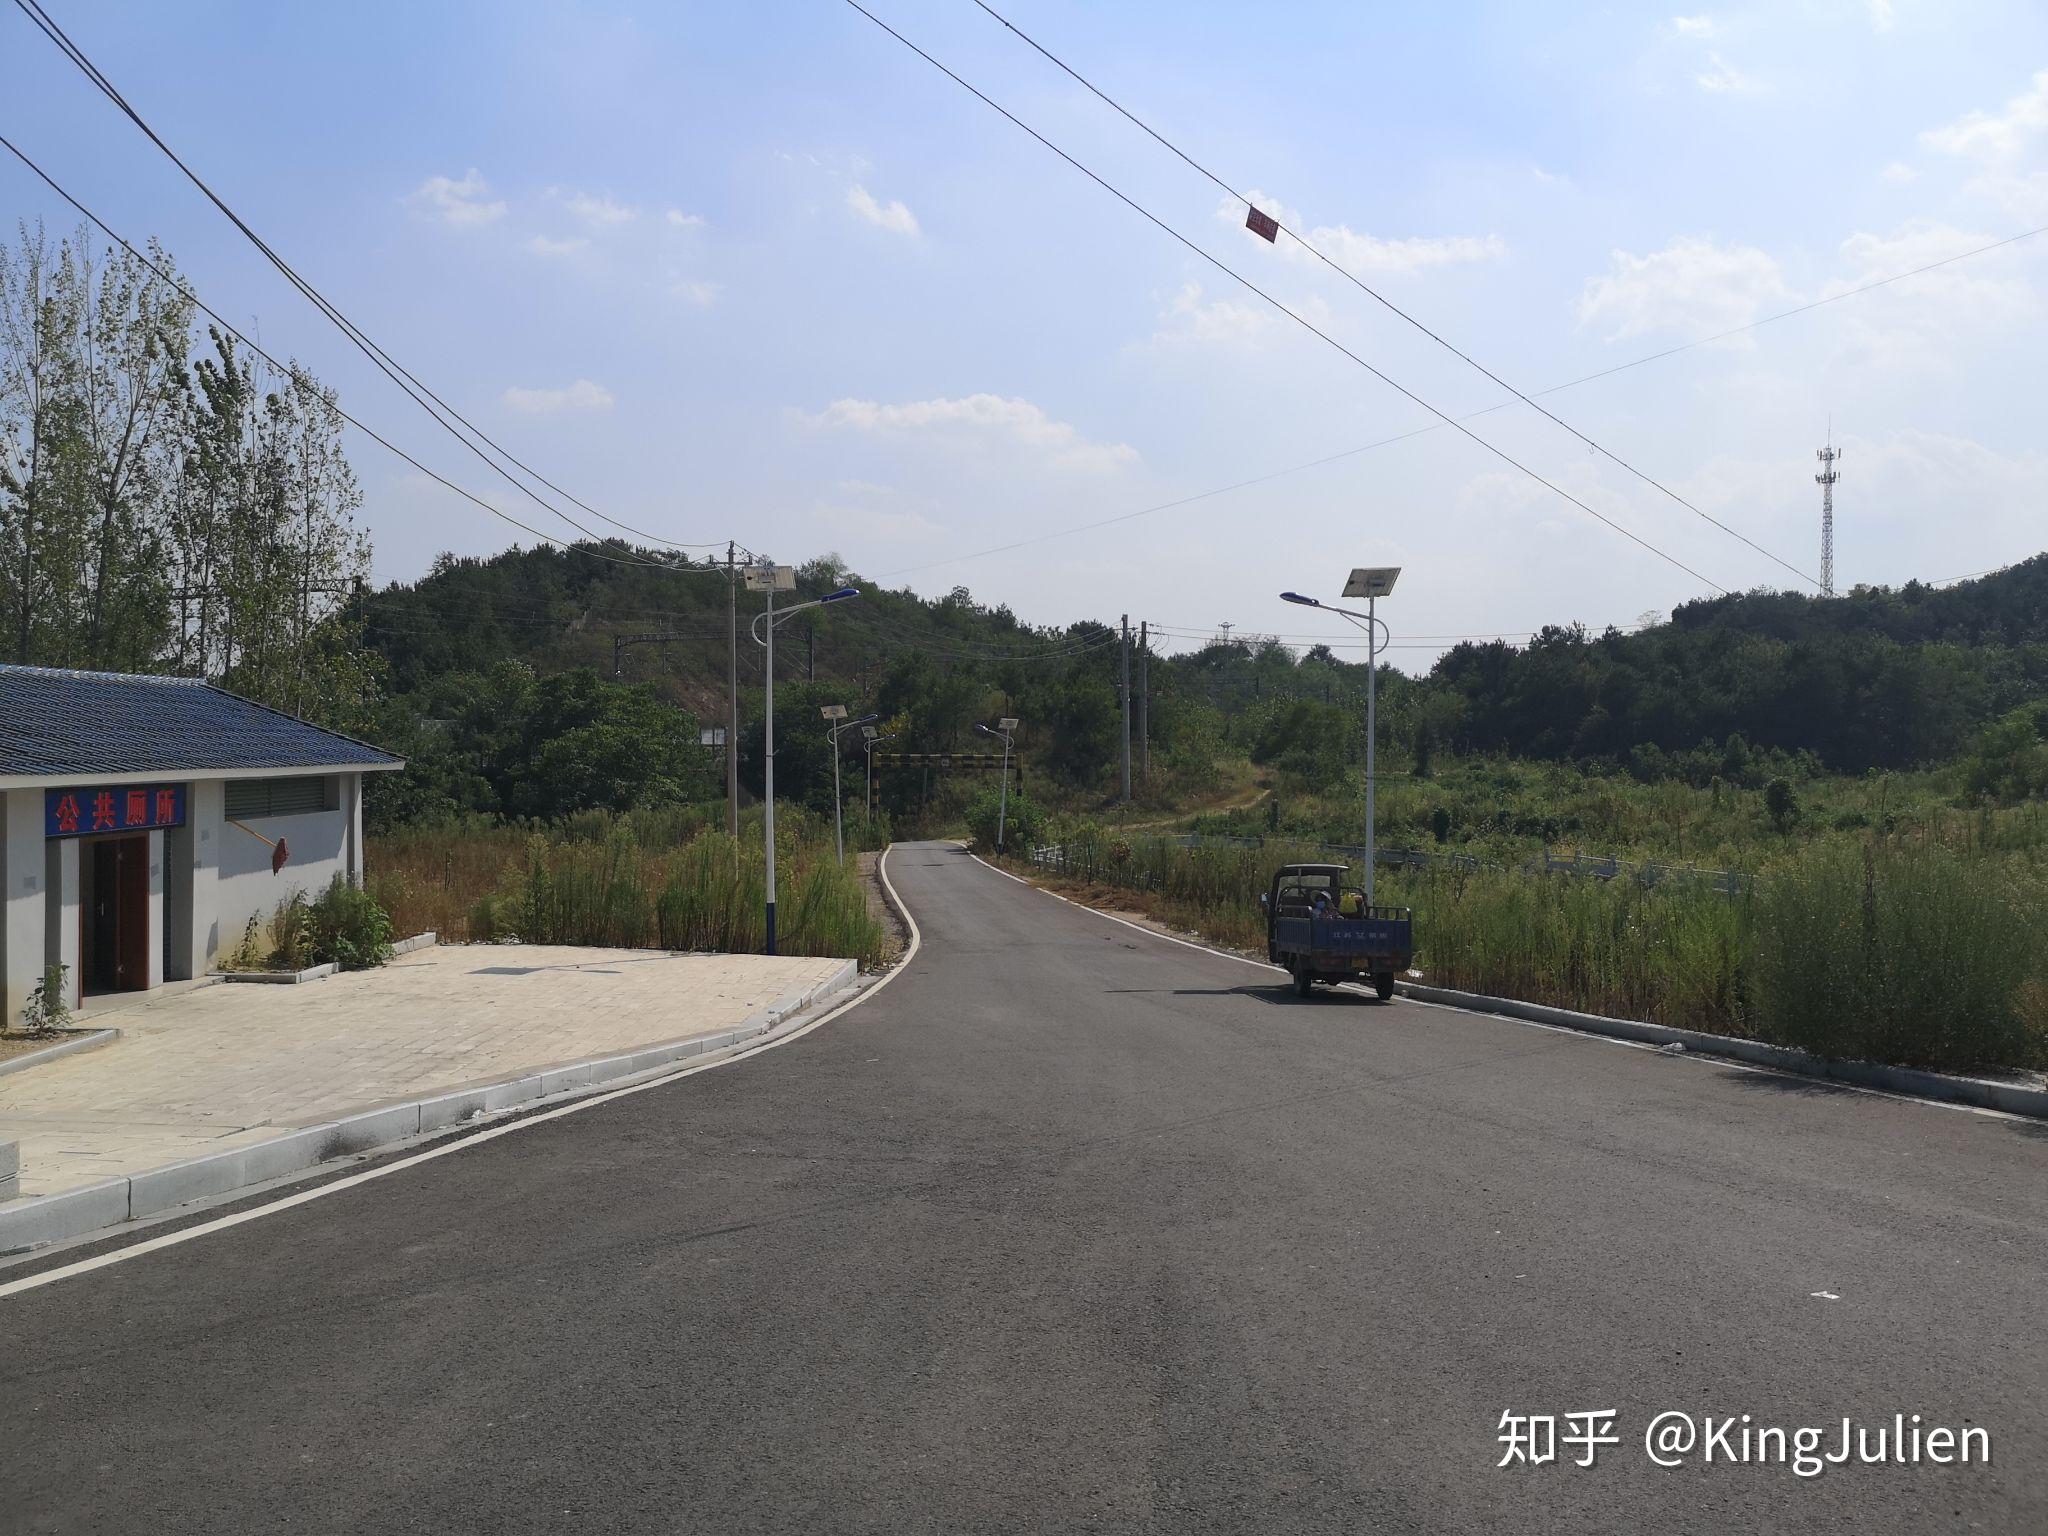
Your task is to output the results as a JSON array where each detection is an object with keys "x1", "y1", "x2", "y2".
[{"x1": 0, "y1": 666, "x2": 406, "y2": 1022}]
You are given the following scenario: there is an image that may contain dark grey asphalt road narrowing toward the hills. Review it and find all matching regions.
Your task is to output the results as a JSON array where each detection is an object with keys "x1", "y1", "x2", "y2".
[{"x1": 0, "y1": 844, "x2": 2048, "y2": 1534}]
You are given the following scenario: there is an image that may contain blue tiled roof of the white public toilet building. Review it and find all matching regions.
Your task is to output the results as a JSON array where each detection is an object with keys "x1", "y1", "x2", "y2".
[{"x1": 0, "y1": 666, "x2": 399, "y2": 778}]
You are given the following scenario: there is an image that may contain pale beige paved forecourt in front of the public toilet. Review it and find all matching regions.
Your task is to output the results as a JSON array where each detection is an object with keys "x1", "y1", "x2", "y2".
[{"x1": 0, "y1": 944, "x2": 842, "y2": 1194}]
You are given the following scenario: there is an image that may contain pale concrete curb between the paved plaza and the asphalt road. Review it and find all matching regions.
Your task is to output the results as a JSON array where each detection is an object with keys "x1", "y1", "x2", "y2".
[{"x1": 0, "y1": 961, "x2": 860, "y2": 1253}]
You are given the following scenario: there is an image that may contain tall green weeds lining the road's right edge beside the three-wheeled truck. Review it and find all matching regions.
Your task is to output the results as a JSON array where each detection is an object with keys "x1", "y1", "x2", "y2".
[{"x1": 1040, "y1": 823, "x2": 2048, "y2": 1069}]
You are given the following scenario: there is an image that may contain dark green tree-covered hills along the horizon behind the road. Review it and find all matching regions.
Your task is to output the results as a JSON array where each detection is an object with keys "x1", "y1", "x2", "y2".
[{"x1": 350, "y1": 545, "x2": 2048, "y2": 831}]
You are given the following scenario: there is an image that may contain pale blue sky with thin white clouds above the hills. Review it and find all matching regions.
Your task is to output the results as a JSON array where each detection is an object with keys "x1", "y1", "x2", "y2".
[{"x1": 0, "y1": 0, "x2": 2048, "y2": 666}]
